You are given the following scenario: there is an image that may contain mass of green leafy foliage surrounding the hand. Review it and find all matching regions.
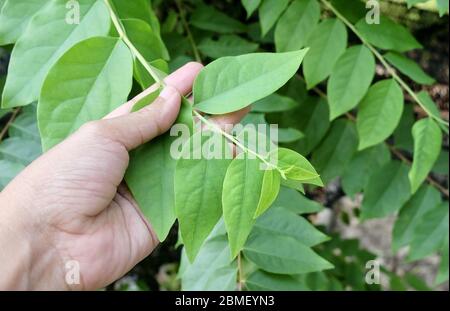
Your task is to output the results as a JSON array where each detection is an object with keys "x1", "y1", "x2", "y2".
[{"x1": 0, "y1": 0, "x2": 449, "y2": 290}]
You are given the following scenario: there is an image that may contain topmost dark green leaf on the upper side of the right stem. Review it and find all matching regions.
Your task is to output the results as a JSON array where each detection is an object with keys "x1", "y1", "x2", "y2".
[{"x1": 355, "y1": 16, "x2": 422, "y2": 52}]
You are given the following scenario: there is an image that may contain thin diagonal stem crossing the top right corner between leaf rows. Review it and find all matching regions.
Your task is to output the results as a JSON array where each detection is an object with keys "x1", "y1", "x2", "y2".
[{"x1": 321, "y1": 0, "x2": 448, "y2": 127}]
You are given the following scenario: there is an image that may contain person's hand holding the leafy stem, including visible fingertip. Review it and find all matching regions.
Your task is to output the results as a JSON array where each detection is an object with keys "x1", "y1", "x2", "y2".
[{"x1": 0, "y1": 63, "x2": 250, "y2": 290}]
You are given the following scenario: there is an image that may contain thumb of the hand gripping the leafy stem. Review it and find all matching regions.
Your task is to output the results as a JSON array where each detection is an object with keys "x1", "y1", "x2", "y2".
[{"x1": 93, "y1": 86, "x2": 181, "y2": 150}]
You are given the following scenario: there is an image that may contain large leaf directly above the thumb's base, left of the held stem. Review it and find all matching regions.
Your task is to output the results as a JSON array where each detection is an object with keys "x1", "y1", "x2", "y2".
[{"x1": 38, "y1": 37, "x2": 133, "y2": 150}]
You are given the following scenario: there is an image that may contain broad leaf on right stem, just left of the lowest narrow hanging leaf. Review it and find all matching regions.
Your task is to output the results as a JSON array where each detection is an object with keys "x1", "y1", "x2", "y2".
[{"x1": 356, "y1": 79, "x2": 403, "y2": 150}]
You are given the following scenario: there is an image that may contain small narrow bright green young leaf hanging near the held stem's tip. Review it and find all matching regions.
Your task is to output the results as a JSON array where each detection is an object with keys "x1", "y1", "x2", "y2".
[{"x1": 254, "y1": 170, "x2": 281, "y2": 218}]
